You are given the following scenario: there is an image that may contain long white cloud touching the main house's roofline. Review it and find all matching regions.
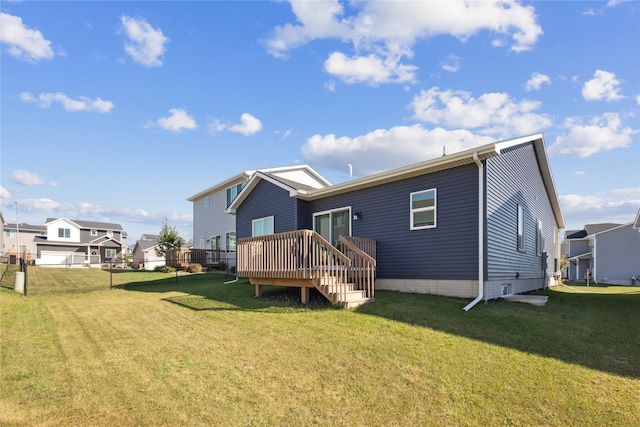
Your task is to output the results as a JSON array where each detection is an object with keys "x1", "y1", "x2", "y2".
[{"x1": 302, "y1": 124, "x2": 494, "y2": 174}]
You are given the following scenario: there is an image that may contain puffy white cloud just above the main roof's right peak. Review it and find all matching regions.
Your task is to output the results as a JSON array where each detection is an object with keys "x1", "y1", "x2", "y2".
[{"x1": 410, "y1": 87, "x2": 552, "y2": 138}]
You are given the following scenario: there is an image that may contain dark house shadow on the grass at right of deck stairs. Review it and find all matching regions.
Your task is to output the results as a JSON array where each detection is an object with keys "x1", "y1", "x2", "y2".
[{"x1": 356, "y1": 290, "x2": 640, "y2": 378}]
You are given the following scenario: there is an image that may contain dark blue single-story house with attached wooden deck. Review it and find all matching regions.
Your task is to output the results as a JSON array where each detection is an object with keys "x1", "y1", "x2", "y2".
[{"x1": 227, "y1": 134, "x2": 565, "y2": 310}]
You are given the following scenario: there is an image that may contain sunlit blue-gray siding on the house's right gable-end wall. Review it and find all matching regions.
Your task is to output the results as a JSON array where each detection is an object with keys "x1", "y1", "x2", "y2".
[{"x1": 486, "y1": 143, "x2": 557, "y2": 283}]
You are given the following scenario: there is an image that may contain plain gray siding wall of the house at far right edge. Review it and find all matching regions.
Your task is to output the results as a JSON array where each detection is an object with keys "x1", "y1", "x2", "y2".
[{"x1": 594, "y1": 224, "x2": 640, "y2": 285}]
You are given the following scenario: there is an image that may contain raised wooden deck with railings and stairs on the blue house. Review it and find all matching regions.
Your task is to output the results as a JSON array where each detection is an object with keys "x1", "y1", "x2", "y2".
[{"x1": 237, "y1": 230, "x2": 376, "y2": 307}]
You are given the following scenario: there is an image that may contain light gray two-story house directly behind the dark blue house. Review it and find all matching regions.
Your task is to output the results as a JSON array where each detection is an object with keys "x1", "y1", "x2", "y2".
[{"x1": 187, "y1": 165, "x2": 331, "y2": 266}]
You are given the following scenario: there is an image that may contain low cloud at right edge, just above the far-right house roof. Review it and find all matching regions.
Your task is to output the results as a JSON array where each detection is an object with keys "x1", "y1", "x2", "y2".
[{"x1": 560, "y1": 187, "x2": 640, "y2": 229}]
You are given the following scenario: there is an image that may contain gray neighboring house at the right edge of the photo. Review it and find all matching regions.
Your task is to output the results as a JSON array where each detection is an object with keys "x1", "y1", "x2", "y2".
[{"x1": 562, "y1": 213, "x2": 640, "y2": 285}]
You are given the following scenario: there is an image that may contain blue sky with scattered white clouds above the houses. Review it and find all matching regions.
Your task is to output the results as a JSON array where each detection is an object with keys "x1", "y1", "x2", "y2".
[{"x1": 0, "y1": 0, "x2": 640, "y2": 243}]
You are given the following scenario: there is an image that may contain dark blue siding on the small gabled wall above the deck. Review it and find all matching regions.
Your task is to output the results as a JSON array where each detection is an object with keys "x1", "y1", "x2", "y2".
[{"x1": 236, "y1": 181, "x2": 299, "y2": 239}]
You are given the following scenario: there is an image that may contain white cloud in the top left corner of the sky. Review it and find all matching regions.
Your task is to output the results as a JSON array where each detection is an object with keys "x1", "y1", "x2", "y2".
[{"x1": 0, "y1": 13, "x2": 54, "y2": 62}]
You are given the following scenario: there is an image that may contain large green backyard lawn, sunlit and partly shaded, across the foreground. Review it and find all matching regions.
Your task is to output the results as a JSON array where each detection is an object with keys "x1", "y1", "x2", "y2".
[{"x1": 0, "y1": 269, "x2": 640, "y2": 426}]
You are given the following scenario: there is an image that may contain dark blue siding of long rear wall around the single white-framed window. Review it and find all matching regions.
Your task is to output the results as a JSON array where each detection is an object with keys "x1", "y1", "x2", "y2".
[{"x1": 309, "y1": 164, "x2": 478, "y2": 280}]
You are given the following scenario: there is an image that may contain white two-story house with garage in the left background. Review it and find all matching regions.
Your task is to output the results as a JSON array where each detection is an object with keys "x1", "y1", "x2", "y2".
[{"x1": 35, "y1": 218, "x2": 127, "y2": 266}]
